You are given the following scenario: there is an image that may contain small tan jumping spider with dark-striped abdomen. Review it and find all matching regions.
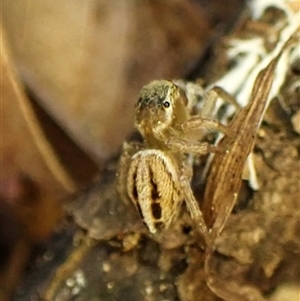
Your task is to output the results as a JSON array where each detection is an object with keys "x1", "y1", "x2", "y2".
[{"x1": 118, "y1": 80, "x2": 234, "y2": 243}]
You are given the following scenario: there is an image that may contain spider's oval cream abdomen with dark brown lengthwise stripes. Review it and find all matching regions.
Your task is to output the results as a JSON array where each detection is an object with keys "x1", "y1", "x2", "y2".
[{"x1": 127, "y1": 149, "x2": 183, "y2": 233}]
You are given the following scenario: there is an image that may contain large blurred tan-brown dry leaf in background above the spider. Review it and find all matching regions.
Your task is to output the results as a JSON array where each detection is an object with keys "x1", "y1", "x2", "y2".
[{"x1": 2, "y1": 0, "x2": 211, "y2": 164}]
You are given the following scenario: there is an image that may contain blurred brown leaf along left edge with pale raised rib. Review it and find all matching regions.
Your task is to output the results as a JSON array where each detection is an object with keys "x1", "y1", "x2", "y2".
[{"x1": 0, "y1": 27, "x2": 75, "y2": 300}]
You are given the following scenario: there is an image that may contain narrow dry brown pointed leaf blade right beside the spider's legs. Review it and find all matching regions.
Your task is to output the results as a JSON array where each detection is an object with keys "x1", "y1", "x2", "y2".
[{"x1": 203, "y1": 37, "x2": 294, "y2": 242}]
